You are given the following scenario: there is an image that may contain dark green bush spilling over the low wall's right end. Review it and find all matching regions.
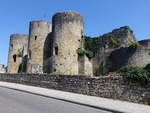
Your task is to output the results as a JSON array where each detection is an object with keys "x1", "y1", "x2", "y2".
[{"x1": 119, "y1": 66, "x2": 150, "y2": 84}]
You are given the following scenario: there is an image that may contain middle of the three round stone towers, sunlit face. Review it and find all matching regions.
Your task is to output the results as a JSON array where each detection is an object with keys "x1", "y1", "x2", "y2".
[{"x1": 27, "y1": 20, "x2": 51, "y2": 73}]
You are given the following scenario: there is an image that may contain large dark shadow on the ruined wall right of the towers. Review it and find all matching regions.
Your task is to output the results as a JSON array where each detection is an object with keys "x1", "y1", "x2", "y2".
[{"x1": 93, "y1": 47, "x2": 140, "y2": 76}]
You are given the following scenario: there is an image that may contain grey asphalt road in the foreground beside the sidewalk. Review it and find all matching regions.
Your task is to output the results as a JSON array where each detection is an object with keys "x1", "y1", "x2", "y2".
[{"x1": 0, "y1": 87, "x2": 110, "y2": 113}]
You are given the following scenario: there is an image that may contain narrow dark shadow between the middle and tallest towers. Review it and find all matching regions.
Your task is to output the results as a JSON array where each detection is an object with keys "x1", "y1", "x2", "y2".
[{"x1": 43, "y1": 32, "x2": 53, "y2": 73}]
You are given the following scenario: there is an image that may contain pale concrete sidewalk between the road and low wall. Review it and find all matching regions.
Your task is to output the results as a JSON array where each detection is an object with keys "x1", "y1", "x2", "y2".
[{"x1": 0, "y1": 82, "x2": 150, "y2": 113}]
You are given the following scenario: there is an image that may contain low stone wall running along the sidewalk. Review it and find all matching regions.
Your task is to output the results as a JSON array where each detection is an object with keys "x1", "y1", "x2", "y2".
[{"x1": 0, "y1": 74, "x2": 150, "y2": 104}]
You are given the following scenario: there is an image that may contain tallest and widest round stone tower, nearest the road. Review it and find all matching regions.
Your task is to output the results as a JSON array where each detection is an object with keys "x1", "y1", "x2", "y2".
[{"x1": 50, "y1": 11, "x2": 83, "y2": 74}]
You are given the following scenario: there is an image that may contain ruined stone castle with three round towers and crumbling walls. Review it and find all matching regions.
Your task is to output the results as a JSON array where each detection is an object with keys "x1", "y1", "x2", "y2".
[{"x1": 7, "y1": 11, "x2": 150, "y2": 75}]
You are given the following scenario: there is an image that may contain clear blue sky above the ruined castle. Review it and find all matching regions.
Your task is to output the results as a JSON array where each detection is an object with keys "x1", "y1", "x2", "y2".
[{"x1": 0, "y1": 0, "x2": 150, "y2": 65}]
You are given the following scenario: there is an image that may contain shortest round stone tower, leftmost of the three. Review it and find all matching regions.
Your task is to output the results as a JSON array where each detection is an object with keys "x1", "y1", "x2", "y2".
[{"x1": 7, "y1": 34, "x2": 28, "y2": 73}]
